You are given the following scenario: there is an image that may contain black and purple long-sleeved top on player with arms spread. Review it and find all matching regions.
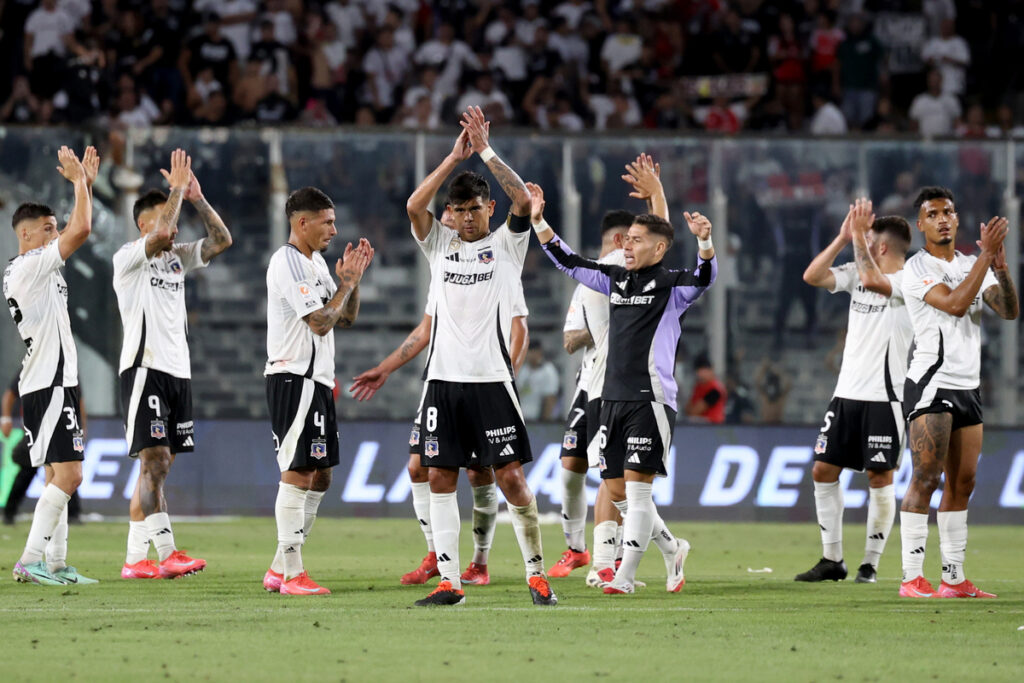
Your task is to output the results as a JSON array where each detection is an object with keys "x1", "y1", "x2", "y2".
[{"x1": 544, "y1": 236, "x2": 718, "y2": 411}]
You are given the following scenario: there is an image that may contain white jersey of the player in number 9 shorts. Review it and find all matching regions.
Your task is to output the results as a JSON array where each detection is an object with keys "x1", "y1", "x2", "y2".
[{"x1": 114, "y1": 238, "x2": 207, "y2": 379}]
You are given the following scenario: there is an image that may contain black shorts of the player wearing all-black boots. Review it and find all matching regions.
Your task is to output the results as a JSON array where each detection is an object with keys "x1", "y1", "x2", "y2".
[{"x1": 814, "y1": 396, "x2": 906, "y2": 472}]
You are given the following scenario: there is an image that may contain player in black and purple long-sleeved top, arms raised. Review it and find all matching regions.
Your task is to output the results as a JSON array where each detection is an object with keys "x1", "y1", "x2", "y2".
[{"x1": 528, "y1": 183, "x2": 718, "y2": 594}]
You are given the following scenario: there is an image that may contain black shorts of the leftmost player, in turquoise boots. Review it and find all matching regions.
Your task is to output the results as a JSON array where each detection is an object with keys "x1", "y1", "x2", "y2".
[{"x1": 22, "y1": 386, "x2": 85, "y2": 467}]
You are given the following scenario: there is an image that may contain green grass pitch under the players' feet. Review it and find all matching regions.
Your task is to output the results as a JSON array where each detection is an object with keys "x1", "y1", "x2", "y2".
[{"x1": 0, "y1": 514, "x2": 1024, "y2": 683}]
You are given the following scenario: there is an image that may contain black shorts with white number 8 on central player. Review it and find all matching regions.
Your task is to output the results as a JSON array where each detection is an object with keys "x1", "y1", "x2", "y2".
[{"x1": 420, "y1": 380, "x2": 534, "y2": 468}]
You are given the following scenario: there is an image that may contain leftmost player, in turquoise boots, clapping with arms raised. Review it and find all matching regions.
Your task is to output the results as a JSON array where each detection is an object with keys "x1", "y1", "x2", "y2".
[{"x1": 3, "y1": 146, "x2": 99, "y2": 586}]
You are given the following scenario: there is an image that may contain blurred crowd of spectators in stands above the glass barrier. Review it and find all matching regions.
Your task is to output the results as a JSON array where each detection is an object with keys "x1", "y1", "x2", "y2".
[{"x1": 6, "y1": 0, "x2": 1024, "y2": 138}]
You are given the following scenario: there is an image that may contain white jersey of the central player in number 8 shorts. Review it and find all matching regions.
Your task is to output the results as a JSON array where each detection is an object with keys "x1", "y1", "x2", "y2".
[{"x1": 414, "y1": 218, "x2": 530, "y2": 382}]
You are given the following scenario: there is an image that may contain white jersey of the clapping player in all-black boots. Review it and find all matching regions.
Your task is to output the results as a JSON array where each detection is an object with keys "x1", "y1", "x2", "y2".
[{"x1": 829, "y1": 263, "x2": 913, "y2": 401}]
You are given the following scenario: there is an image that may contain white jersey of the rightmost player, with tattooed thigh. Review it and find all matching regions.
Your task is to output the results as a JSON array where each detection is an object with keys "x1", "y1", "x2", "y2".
[{"x1": 903, "y1": 249, "x2": 999, "y2": 389}]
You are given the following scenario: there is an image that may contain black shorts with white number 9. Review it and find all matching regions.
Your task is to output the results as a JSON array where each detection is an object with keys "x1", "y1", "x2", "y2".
[{"x1": 121, "y1": 368, "x2": 196, "y2": 458}]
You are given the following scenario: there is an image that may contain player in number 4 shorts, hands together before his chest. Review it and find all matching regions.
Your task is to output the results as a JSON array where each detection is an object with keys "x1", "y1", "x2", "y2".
[{"x1": 263, "y1": 187, "x2": 374, "y2": 595}]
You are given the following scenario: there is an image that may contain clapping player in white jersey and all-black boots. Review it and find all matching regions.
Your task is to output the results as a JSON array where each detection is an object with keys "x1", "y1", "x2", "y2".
[{"x1": 796, "y1": 199, "x2": 913, "y2": 584}]
